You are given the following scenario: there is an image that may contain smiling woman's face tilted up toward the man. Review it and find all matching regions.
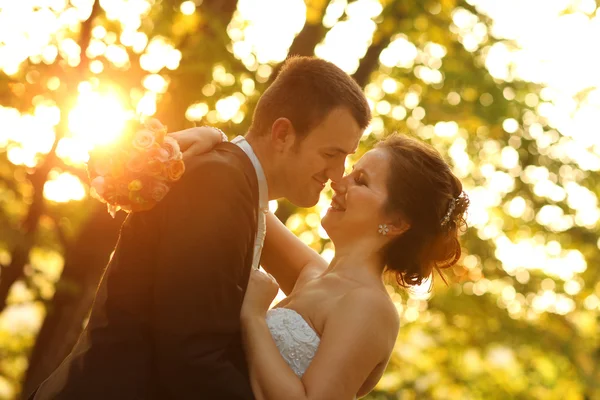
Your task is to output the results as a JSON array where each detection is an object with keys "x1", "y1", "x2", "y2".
[{"x1": 322, "y1": 149, "x2": 390, "y2": 243}]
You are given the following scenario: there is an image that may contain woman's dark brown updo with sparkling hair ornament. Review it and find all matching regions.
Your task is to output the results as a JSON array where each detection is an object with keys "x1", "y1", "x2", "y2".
[{"x1": 377, "y1": 134, "x2": 469, "y2": 287}]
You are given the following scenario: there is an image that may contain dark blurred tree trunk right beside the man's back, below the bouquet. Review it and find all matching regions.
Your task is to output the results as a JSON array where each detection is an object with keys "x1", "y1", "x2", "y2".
[{"x1": 22, "y1": 204, "x2": 124, "y2": 395}]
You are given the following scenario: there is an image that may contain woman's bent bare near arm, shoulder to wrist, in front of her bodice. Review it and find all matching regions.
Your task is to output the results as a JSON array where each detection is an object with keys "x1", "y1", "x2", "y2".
[{"x1": 241, "y1": 284, "x2": 398, "y2": 400}]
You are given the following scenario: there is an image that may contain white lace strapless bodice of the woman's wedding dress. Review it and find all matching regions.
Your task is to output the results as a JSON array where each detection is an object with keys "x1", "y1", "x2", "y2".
[{"x1": 267, "y1": 308, "x2": 321, "y2": 377}]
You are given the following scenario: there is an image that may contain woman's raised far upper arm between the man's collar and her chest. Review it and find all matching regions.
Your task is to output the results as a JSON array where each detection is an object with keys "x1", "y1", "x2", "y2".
[{"x1": 260, "y1": 212, "x2": 328, "y2": 295}]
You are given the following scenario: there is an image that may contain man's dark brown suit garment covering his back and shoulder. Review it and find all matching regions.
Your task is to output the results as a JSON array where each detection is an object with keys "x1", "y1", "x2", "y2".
[{"x1": 31, "y1": 143, "x2": 258, "y2": 400}]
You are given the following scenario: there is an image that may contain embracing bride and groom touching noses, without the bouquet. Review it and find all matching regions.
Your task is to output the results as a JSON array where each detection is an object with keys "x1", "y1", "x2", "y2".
[{"x1": 31, "y1": 58, "x2": 468, "y2": 400}]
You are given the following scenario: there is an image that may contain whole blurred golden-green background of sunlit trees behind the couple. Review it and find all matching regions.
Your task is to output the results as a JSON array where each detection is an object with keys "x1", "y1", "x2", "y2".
[{"x1": 0, "y1": 0, "x2": 600, "y2": 400}]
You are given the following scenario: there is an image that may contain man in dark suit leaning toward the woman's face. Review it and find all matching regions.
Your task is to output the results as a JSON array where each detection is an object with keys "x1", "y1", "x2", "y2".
[{"x1": 31, "y1": 57, "x2": 370, "y2": 400}]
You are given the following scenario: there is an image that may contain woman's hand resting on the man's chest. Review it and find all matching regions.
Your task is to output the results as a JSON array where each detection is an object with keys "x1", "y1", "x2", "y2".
[{"x1": 241, "y1": 270, "x2": 279, "y2": 319}]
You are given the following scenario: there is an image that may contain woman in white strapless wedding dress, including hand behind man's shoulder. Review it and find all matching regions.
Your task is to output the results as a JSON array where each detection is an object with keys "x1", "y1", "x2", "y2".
[{"x1": 172, "y1": 127, "x2": 469, "y2": 400}]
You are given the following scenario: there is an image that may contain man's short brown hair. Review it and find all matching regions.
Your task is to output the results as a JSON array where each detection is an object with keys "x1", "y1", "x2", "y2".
[{"x1": 250, "y1": 56, "x2": 371, "y2": 137}]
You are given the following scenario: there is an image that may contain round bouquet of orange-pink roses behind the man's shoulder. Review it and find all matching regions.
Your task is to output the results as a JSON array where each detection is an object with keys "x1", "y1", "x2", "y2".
[{"x1": 88, "y1": 119, "x2": 185, "y2": 218}]
